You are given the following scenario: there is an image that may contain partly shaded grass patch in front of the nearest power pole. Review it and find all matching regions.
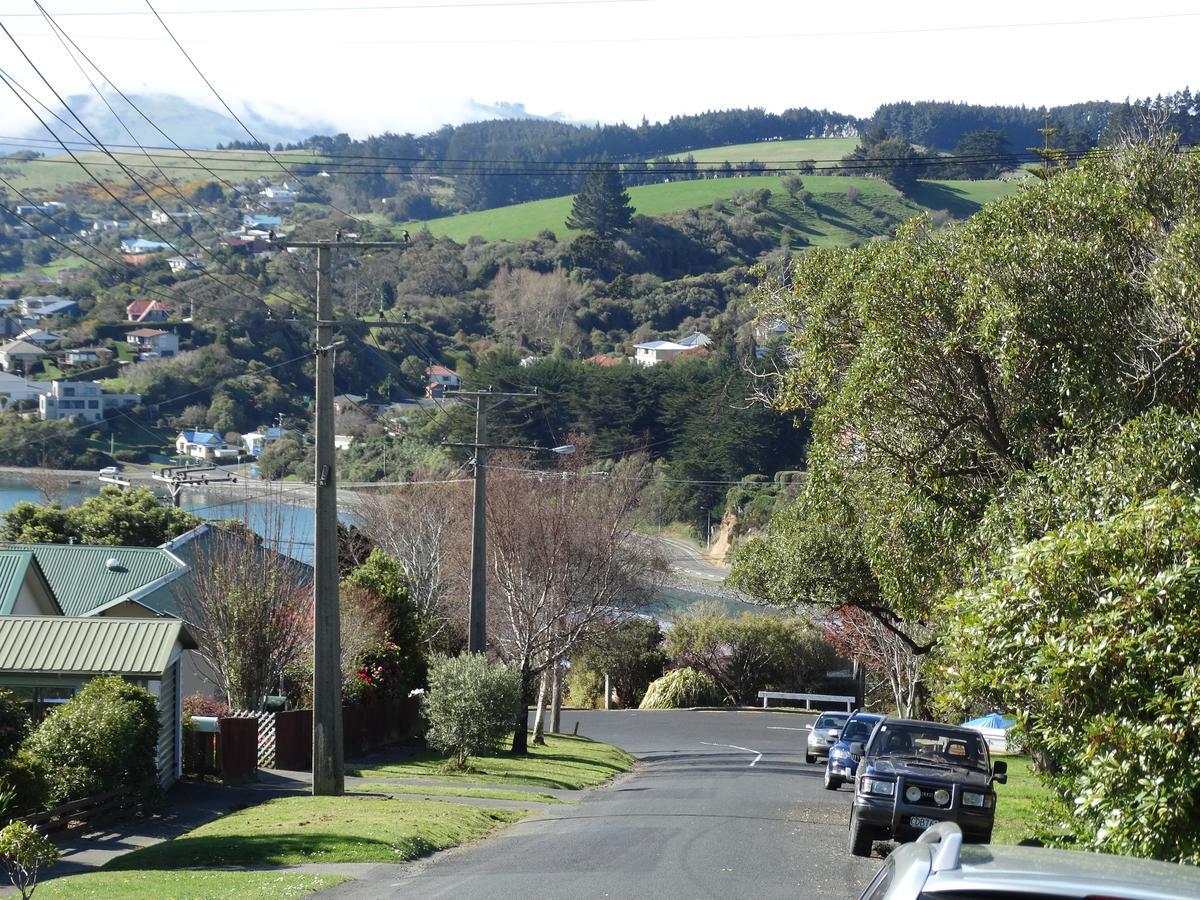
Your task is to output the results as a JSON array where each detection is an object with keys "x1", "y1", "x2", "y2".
[{"x1": 98, "y1": 794, "x2": 526, "y2": 870}]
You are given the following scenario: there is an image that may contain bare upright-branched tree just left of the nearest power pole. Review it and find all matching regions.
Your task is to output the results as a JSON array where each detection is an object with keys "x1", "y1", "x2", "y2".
[{"x1": 180, "y1": 528, "x2": 312, "y2": 709}]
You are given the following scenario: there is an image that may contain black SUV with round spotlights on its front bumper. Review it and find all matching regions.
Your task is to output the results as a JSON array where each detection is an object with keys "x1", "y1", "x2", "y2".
[{"x1": 850, "y1": 719, "x2": 1008, "y2": 857}]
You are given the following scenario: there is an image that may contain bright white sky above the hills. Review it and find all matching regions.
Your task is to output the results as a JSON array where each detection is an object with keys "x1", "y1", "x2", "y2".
[{"x1": 0, "y1": 0, "x2": 1200, "y2": 137}]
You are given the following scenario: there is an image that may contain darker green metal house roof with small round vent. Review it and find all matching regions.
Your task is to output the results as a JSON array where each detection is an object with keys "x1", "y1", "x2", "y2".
[{"x1": 0, "y1": 544, "x2": 186, "y2": 616}]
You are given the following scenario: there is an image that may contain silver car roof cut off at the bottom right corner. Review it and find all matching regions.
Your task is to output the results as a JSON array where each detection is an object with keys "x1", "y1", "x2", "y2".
[{"x1": 860, "y1": 822, "x2": 1200, "y2": 900}]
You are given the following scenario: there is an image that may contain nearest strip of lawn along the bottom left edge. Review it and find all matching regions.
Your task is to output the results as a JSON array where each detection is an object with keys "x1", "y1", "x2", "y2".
[{"x1": 36, "y1": 871, "x2": 349, "y2": 900}]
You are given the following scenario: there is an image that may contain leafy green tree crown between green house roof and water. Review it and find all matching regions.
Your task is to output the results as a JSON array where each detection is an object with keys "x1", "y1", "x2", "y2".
[{"x1": 0, "y1": 486, "x2": 200, "y2": 547}]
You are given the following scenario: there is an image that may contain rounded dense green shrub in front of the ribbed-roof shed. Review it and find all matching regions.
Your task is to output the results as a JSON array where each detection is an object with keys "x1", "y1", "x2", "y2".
[{"x1": 25, "y1": 676, "x2": 158, "y2": 804}]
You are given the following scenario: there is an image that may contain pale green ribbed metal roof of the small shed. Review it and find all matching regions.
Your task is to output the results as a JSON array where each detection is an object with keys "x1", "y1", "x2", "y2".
[{"x1": 0, "y1": 616, "x2": 196, "y2": 678}]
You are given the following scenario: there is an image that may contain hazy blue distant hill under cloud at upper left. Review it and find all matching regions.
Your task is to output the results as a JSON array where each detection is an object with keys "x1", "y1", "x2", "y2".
[{"x1": 23, "y1": 91, "x2": 336, "y2": 149}]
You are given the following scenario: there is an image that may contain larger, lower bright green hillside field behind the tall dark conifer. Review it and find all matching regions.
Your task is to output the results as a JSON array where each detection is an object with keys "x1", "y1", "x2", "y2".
[{"x1": 397, "y1": 174, "x2": 1016, "y2": 246}]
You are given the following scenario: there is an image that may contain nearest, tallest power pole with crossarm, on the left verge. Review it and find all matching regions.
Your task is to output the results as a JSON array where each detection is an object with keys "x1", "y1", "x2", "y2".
[{"x1": 276, "y1": 240, "x2": 404, "y2": 797}]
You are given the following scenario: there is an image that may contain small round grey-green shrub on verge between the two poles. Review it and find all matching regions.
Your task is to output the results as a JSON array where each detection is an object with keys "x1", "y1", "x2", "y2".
[{"x1": 424, "y1": 653, "x2": 521, "y2": 769}]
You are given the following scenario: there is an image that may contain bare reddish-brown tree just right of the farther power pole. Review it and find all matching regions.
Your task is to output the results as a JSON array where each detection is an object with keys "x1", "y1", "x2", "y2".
[{"x1": 487, "y1": 448, "x2": 662, "y2": 754}]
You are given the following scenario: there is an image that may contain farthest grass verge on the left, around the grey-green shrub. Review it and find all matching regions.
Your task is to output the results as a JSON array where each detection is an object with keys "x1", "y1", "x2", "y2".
[{"x1": 348, "y1": 734, "x2": 634, "y2": 791}]
